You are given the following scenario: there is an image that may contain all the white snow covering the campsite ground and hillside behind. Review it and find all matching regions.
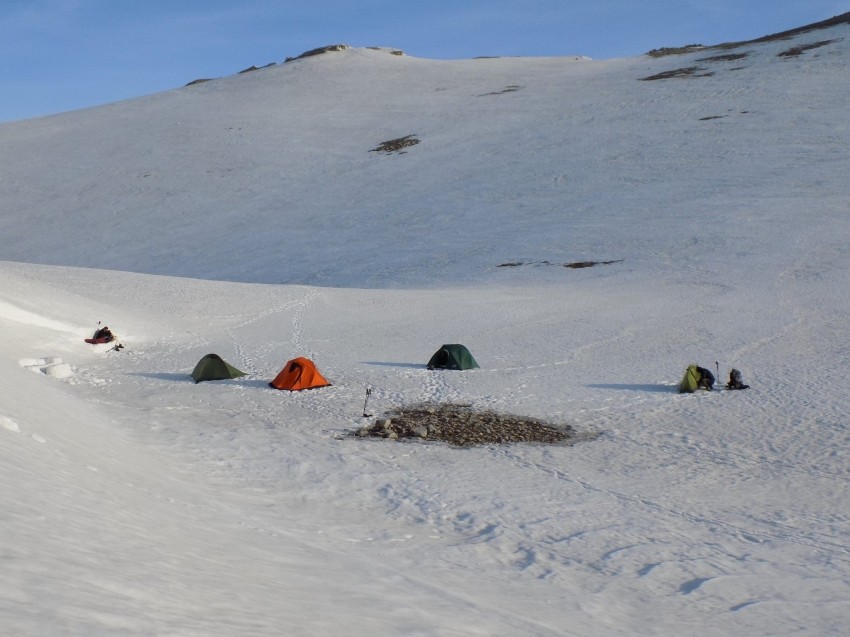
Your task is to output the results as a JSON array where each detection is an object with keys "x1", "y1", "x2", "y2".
[{"x1": 0, "y1": 25, "x2": 850, "y2": 637}]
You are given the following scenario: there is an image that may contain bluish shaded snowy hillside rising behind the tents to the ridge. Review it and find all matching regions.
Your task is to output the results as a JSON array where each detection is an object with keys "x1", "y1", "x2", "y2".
[{"x1": 0, "y1": 25, "x2": 850, "y2": 287}]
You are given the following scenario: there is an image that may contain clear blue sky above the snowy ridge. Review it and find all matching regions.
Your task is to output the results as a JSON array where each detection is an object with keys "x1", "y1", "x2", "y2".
[{"x1": 0, "y1": 0, "x2": 850, "y2": 122}]
